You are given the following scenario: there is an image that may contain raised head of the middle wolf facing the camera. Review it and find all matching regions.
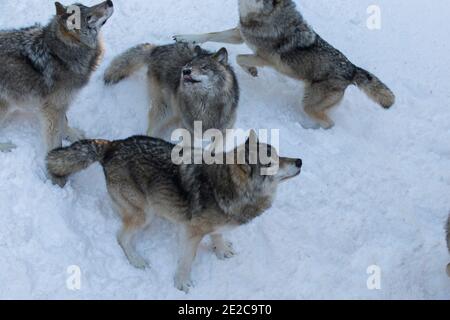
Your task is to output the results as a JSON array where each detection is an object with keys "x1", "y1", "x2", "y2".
[{"x1": 181, "y1": 46, "x2": 230, "y2": 92}]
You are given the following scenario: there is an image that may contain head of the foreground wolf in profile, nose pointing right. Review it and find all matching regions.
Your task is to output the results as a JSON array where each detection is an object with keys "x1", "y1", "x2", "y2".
[{"x1": 232, "y1": 130, "x2": 303, "y2": 193}]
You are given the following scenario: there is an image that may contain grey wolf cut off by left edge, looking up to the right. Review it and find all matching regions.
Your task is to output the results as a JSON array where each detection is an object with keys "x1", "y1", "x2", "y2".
[{"x1": 0, "y1": 0, "x2": 114, "y2": 151}]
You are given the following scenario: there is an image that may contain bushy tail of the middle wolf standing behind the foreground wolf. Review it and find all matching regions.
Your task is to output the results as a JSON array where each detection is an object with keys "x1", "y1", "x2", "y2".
[{"x1": 104, "y1": 43, "x2": 155, "y2": 85}]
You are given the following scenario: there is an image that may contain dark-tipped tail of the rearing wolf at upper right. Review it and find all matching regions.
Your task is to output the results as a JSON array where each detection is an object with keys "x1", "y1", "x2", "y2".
[{"x1": 353, "y1": 67, "x2": 395, "y2": 109}]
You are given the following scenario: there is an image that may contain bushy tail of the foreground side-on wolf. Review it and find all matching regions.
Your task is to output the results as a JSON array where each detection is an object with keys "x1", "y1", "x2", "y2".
[{"x1": 47, "y1": 140, "x2": 111, "y2": 178}]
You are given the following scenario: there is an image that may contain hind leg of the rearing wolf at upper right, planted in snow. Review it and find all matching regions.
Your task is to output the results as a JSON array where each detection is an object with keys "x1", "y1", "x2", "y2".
[{"x1": 303, "y1": 82, "x2": 345, "y2": 129}]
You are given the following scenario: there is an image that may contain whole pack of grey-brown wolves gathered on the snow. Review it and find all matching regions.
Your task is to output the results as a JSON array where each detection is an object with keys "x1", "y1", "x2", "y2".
[{"x1": 0, "y1": 0, "x2": 450, "y2": 293}]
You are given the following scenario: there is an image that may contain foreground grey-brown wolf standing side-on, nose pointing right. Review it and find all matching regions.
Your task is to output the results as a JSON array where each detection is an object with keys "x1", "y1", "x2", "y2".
[{"x1": 47, "y1": 131, "x2": 302, "y2": 293}]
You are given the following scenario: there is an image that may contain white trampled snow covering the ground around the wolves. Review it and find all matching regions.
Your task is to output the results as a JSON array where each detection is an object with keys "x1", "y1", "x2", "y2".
[{"x1": 0, "y1": 0, "x2": 450, "y2": 299}]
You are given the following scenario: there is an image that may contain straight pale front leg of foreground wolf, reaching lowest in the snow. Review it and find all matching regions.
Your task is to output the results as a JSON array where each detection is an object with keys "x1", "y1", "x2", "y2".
[{"x1": 175, "y1": 227, "x2": 204, "y2": 293}]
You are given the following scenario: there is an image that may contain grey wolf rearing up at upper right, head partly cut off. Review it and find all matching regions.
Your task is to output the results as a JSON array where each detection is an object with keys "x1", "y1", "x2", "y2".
[{"x1": 174, "y1": 0, "x2": 395, "y2": 129}]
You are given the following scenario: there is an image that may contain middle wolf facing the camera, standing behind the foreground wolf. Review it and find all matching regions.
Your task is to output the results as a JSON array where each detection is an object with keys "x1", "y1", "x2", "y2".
[{"x1": 104, "y1": 43, "x2": 239, "y2": 139}]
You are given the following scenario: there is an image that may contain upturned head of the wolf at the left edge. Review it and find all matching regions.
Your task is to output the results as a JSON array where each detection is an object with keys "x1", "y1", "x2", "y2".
[{"x1": 55, "y1": 0, "x2": 114, "y2": 49}]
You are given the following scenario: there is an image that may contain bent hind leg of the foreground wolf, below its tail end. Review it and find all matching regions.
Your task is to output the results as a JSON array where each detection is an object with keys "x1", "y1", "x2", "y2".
[{"x1": 117, "y1": 208, "x2": 153, "y2": 269}]
